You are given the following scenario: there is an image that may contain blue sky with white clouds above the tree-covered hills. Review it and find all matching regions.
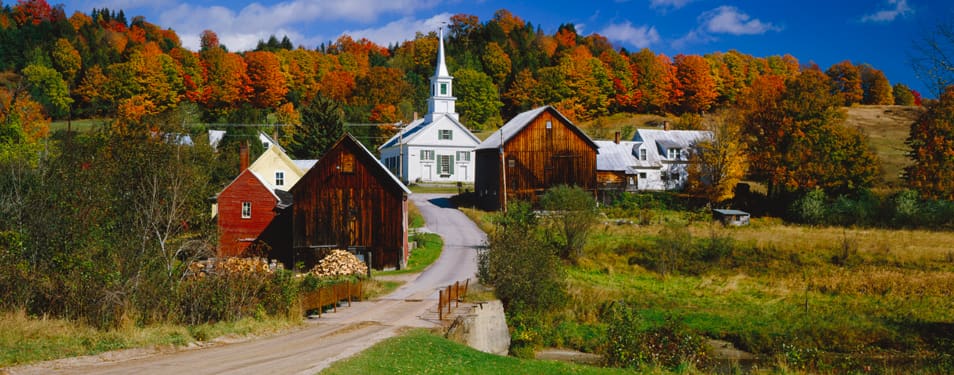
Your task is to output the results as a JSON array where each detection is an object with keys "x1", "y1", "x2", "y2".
[{"x1": 63, "y1": 0, "x2": 954, "y2": 96}]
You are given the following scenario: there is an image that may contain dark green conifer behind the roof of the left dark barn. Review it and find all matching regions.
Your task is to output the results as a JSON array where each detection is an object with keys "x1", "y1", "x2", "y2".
[{"x1": 285, "y1": 95, "x2": 344, "y2": 159}]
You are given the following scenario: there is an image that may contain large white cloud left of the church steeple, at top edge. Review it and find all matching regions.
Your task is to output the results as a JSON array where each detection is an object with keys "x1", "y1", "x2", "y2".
[{"x1": 154, "y1": 0, "x2": 440, "y2": 51}]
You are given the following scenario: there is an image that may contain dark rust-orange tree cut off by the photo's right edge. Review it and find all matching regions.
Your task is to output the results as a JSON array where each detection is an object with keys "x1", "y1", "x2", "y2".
[{"x1": 904, "y1": 86, "x2": 954, "y2": 200}]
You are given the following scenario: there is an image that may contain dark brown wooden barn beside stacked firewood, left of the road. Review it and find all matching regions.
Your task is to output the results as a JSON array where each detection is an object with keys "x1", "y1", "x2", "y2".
[{"x1": 291, "y1": 134, "x2": 411, "y2": 269}]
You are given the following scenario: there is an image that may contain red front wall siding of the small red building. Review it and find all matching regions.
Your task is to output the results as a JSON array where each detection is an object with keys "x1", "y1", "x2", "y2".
[{"x1": 217, "y1": 171, "x2": 278, "y2": 257}]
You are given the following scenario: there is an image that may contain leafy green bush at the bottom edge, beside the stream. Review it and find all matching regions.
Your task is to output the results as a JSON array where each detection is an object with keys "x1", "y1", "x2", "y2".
[{"x1": 603, "y1": 303, "x2": 709, "y2": 369}]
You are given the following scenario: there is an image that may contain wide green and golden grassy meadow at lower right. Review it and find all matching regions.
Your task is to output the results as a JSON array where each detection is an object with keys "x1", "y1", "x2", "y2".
[{"x1": 466, "y1": 204, "x2": 954, "y2": 373}]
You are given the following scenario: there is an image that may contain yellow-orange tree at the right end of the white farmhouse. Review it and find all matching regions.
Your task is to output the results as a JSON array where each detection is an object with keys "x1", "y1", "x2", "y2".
[{"x1": 686, "y1": 112, "x2": 748, "y2": 203}]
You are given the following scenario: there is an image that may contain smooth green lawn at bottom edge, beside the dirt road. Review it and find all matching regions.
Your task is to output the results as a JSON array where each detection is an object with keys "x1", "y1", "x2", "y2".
[{"x1": 321, "y1": 330, "x2": 630, "y2": 375}]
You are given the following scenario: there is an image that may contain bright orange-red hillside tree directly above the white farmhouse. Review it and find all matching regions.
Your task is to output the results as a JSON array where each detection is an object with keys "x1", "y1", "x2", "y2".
[{"x1": 674, "y1": 54, "x2": 718, "y2": 113}]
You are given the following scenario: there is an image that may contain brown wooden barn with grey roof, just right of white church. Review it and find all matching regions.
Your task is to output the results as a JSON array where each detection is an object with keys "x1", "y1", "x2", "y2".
[{"x1": 474, "y1": 106, "x2": 598, "y2": 210}]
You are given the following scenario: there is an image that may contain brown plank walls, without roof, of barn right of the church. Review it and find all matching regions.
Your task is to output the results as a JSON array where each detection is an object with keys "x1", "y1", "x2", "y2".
[{"x1": 475, "y1": 109, "x2": 597, "y2": 209}]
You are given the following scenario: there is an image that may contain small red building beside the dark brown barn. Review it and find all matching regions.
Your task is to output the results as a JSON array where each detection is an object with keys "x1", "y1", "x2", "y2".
[{"x1": 217, "y1": 169, "x2": 291, "y2": 257}]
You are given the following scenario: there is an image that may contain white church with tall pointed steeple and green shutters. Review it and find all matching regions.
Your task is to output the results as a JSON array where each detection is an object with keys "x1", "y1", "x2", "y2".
[{"x1": 378, "y1": 29, "x2": 480, "y2": 183}]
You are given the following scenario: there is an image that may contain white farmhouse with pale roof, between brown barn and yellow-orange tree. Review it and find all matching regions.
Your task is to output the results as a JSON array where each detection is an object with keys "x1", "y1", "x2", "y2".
[{"x1": 612, "y1": 129, "x2": 712, "y2": 190}]
